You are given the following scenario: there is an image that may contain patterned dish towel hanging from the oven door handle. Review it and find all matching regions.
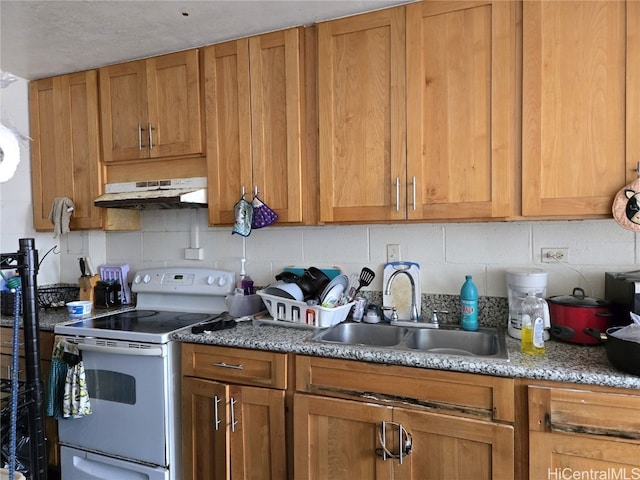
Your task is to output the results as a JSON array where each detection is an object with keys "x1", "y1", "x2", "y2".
[{"x1": 45, "y1": 340, "x2": 91, "y2": 419}]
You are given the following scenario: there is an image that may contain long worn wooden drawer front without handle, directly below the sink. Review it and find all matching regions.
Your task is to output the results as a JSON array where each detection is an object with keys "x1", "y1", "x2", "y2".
[{"x1": 296, "y1": 356, "x2": 515, "y2": 422}]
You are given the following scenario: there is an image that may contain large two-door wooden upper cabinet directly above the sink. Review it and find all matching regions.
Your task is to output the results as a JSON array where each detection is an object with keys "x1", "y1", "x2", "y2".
[{"x1": 318, "y1": 1, "x2": 517, "y2": 222}]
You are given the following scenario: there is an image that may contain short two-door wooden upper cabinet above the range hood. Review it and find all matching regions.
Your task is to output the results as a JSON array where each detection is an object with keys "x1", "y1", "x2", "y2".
[{"x1": 100, "y1": 50, "x2": 203, "y2": 162}]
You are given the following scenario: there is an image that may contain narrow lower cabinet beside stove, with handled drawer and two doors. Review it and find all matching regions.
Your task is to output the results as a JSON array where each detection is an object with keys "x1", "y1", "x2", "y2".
[{"x1": 182, "y1": 344, "x2": 287, "y2": 480}]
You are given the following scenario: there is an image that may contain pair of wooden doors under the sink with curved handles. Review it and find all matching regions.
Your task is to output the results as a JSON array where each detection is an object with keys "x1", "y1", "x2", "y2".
[{"x1": 294, "y1": 394, "x2": 514, "y2": 480}]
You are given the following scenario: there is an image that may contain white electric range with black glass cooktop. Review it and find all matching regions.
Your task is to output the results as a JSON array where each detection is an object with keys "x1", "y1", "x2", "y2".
[{"x1": 54, "y1": 267, "x2": 236, "y2": 480}]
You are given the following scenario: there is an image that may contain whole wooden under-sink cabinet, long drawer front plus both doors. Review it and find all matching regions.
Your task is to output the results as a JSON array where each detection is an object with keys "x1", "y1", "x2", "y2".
[{"x1": 293, "y1": 357, "x2": 515, "y2": 480}]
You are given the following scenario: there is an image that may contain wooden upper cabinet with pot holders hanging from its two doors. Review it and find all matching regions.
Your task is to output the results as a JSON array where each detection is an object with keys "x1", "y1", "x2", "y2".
[{"x1": 204, "y1": 28, "x2": 304, "y2": 225}]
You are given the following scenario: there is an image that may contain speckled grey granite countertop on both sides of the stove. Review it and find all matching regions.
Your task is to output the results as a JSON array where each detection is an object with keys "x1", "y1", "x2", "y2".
[{"x1": 0, "y1": 306, "x2": 640, "y2": 390}]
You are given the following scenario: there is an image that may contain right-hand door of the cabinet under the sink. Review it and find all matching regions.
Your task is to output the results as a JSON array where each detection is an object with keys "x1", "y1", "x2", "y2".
[{"x1": 393, "y1": 408, "x2": 516, "y2": 480}]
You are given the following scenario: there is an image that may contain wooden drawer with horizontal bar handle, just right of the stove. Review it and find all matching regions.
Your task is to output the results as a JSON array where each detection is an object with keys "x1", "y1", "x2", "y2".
[{"x1": 182, "y1": 343, "x2": 287, "y2": 390}]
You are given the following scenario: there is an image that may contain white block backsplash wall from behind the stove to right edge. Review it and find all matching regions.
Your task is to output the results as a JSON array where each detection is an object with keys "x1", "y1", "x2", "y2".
[{"x1": 102, "y1": 210, "x2": 639, "y2": 297}]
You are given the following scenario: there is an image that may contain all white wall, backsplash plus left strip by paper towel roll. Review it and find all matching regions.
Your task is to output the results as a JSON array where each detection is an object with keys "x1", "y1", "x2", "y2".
[{"x1": 0, "y1": 73, "x2": 640, "y2": 297}]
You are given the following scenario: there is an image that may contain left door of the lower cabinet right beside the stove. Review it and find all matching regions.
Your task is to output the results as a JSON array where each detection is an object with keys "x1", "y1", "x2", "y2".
[{"x1": 182, "y1": 377, "x2": 231, "y2": 480}]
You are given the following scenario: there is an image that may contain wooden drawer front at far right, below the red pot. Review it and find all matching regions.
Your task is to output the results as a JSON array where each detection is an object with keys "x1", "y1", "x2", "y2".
[{"x1": 528, "y1": 386, "x2": 640, "y2": 440}]
